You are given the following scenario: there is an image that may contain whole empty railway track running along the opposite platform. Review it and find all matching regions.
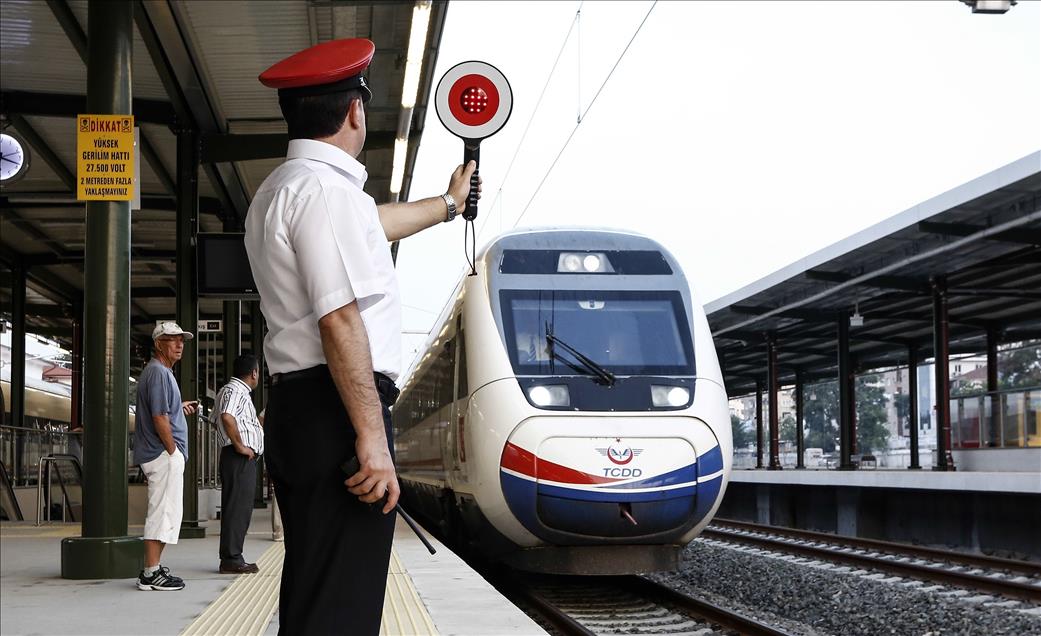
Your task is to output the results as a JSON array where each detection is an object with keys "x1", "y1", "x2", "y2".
[{"x1": 702, "y1": 519, "x2": 1041, "y2": 603}]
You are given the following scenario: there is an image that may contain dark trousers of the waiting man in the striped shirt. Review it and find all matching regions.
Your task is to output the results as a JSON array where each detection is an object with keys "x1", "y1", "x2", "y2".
[{"x1": 220, "y1": 446, "x2": 257, "y2": 565}]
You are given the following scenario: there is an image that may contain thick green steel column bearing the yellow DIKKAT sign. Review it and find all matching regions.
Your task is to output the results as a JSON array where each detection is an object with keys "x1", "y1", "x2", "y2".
[{"x1": 61, "y1": 0, "x2": 144, "y2": 579}]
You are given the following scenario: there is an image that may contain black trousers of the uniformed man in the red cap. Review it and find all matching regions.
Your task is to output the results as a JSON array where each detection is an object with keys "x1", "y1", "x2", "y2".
[{"x1": 264, "y1": 375, "x2": 396, "y2": 636}]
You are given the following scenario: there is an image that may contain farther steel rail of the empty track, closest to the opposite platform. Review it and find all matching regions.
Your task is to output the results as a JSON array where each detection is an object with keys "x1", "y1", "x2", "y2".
[{"x1": 712, "y1": 517, "x2": 1041, "y2": 578}]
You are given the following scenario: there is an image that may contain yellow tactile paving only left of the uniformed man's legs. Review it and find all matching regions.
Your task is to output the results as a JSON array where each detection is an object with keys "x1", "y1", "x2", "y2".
[{"x1": 181, "y1": 543, "x2": 285, "y2": 636}]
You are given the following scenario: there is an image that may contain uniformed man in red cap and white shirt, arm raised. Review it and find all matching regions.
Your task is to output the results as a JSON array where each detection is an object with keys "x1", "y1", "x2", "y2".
[{"x1": 246, "y1": 39, "x2": 475, "y2": 635}]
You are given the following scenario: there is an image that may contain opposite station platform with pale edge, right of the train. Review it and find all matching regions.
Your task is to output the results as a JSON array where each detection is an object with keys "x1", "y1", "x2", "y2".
[{"x1": 716, "y1": 467, "x2": 1041, "y2": 561}]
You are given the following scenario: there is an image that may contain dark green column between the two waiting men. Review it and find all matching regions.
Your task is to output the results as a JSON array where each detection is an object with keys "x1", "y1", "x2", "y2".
[{"x1": 174, "y1": 129, "x2": 206, "y2": 539}]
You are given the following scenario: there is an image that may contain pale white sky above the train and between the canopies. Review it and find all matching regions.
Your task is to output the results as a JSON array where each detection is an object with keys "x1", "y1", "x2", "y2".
[{"x1": 398, "y1": 0, "x2": 1041, "y2": 368}]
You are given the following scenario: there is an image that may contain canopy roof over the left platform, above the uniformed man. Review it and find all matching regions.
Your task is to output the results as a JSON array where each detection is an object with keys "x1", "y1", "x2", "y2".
[{"x1": 0, "y1": 0, "x2": 448, "y2": 364}]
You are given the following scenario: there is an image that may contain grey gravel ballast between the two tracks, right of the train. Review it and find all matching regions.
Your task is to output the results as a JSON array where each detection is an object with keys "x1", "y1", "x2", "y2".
[{"x1": 650, "y1": 539, "x2": 1041, "y2": 636}]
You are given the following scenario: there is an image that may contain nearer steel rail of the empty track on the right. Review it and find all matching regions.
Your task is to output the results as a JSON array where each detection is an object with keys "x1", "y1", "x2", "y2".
[{"x1": 702, "y1": 528, "x2": 1041, "y2": 603}]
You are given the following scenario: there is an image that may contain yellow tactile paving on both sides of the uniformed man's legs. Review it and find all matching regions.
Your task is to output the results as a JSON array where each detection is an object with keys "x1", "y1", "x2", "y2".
[{"x1": 181, "y1": 543, "x2": 437, "y2": 636}]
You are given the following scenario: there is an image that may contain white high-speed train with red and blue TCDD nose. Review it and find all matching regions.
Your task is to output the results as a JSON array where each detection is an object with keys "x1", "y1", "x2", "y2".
[{"x1": 392, "y1": 229, "x2": 732, "y2": 575}]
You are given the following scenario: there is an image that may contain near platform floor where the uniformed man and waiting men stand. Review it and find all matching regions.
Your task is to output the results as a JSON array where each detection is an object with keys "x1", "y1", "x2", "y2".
[{"x1": 0, "y1": 509, "x2": 545, "y2": 636}]
